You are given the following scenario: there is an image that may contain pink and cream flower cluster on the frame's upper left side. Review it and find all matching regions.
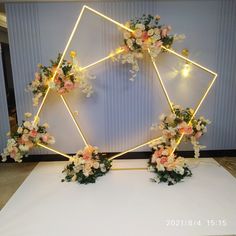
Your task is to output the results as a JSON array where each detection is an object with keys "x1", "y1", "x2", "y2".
[{"x1": 27, "y1": 51, "x2": 95, "y2": 106}]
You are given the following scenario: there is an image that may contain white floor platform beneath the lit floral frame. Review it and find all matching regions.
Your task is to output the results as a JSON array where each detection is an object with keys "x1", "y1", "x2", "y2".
[{"x1": 0, "y1": 159, "x2": 236, "y2": 236}]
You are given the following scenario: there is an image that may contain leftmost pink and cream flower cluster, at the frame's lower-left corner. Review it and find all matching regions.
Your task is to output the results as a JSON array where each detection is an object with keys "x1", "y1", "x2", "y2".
[{"x1": 1, "y1": 113, "x2": 55, "y2": 162}]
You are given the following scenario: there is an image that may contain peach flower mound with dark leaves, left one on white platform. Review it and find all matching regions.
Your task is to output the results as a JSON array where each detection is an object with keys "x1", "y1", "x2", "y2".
[{"x1": 62, "y1": 145, "x2": 112, "y2": 184}]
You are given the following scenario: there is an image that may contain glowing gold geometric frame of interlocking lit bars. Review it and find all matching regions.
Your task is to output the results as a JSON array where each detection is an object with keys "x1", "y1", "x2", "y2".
[{"x1": 34, "y1": 5, "x2": 217, "y2": 166}]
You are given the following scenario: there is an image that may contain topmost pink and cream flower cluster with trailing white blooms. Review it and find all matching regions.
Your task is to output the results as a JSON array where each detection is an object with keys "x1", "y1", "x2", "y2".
[{"x1": 117, "y1": 14, "x2": 174, "y2": 80}]
